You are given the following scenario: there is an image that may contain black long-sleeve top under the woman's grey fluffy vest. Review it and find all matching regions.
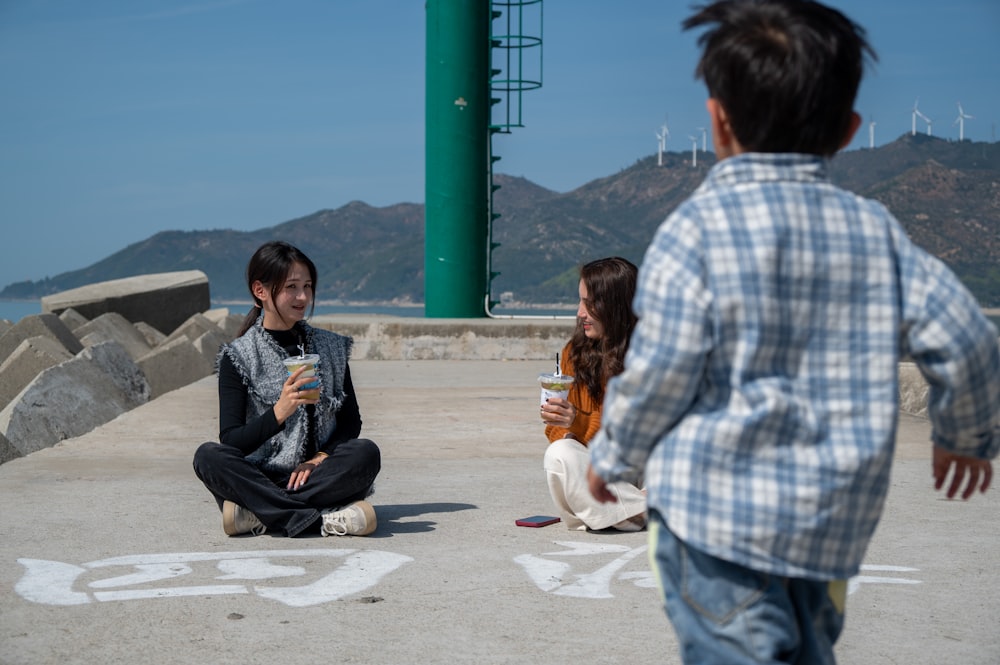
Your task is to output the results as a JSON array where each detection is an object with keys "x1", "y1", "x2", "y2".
[{"x1": 219, "y1": 330, "x2": 361, "y2": 459}]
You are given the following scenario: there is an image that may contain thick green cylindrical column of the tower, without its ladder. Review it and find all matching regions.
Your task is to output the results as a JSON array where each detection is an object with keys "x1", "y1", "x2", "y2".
[{"x1": 424, "y1": 0, "x2": 491, "y2": 318}]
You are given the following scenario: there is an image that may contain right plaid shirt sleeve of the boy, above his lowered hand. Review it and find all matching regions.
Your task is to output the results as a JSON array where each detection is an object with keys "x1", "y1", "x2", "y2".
[{"x1": 899, "y1": 226, "x2": 1000, "y2": 459}]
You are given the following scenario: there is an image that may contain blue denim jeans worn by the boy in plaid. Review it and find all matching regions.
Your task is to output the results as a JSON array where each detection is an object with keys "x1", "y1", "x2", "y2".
[{"x1": 649, "y1": 510, "x2": 847, "y2": 665}]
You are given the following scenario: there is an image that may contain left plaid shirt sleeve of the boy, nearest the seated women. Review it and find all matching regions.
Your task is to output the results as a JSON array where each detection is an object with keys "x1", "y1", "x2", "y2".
[{"x1": 589, "y1": 212, "x2": 712, "y2": 483}]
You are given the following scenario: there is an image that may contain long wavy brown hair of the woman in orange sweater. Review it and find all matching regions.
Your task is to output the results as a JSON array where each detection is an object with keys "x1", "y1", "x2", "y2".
[{"x1": 570, "y1": 256, "x2": 639, "y2": 403}]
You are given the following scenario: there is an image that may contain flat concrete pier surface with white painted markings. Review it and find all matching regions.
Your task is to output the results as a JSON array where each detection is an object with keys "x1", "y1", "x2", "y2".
[{"x1": 0, "y1": 360, "x2": 1000, "y2": 665}]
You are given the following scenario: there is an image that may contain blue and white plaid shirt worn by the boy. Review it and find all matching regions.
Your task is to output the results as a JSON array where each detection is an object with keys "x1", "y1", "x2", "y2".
[{"x1": 590, "y1": 153, "x2": 1000, "y2": 579}]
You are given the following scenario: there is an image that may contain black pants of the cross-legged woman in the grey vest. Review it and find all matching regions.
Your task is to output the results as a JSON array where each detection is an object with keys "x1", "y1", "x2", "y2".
[{"x1": 194, "y1": 439, "x2": 382, "y2": 536}]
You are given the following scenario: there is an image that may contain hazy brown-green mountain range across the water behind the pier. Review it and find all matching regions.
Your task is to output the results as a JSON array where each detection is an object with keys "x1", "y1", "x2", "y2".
[{"x1": 0, "y1": 134, "x2": 1000, "y2": 307}]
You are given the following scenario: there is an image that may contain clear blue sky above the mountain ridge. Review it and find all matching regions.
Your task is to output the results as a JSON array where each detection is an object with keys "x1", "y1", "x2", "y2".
[{"x1": 0, "y1": 0, "x2": 1000, "y2": 287}]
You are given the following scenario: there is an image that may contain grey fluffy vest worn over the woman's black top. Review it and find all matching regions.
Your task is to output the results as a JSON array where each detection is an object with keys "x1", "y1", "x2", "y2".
[{"x1": 220, "y1": 316, "x2": 354, "y2": 473}]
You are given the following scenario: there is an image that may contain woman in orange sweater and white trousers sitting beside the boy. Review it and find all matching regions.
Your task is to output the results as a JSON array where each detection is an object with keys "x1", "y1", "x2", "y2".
[{"x1": 542, "y1": 257, "x2": 646, "y2": 531}]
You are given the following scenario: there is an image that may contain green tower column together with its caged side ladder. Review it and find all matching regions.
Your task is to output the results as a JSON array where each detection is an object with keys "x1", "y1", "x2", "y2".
[{"x1": 424, "y1": 0, "x2": 541, "y2": 318}]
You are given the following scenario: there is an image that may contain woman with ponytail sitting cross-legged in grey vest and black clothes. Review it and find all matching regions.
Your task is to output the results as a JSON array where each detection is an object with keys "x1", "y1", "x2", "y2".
[{"x1": 194, "y1": 241, "x2": 381, "y2": 536}]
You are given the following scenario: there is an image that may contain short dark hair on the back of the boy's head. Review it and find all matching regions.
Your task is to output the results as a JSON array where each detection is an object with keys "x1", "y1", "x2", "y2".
[{"x1": 682, "y1": 0, "x2": 878, "y2": 156}]
